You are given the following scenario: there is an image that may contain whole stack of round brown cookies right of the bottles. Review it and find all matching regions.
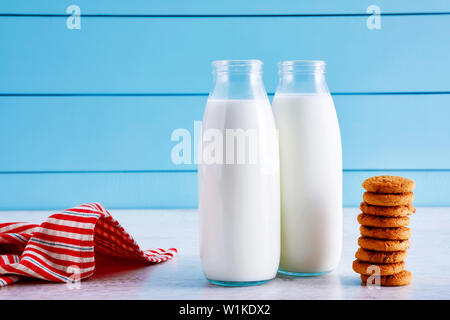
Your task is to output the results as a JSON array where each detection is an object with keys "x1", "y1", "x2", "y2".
[{"x1": 353, "y1": 176, "x2": 416, "y2": 286}]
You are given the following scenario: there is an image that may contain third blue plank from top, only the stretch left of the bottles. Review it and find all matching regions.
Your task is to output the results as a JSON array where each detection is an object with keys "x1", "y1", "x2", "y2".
[{"x1": 0, "y1": 97, "x2": 202, "y2": 171}]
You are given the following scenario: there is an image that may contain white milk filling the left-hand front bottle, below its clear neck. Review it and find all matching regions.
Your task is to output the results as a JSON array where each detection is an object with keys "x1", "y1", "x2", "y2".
[{"x1": 199, "y1": 98, "x2": 280, "y2": 282}]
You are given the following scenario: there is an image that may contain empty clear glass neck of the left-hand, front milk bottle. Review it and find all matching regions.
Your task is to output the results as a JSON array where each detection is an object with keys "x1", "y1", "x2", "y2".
[{"x1": 210, "y1": 60, "x2": 267, "y2": 100}]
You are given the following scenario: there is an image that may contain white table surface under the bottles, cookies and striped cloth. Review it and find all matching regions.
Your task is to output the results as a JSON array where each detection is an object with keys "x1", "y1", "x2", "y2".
[{"x1": 0, "y1": 208, "x2": 450, "y2": 300}]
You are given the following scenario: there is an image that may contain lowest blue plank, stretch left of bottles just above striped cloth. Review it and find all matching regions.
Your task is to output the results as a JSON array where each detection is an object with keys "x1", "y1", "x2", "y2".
[{"x1": 0, "y1": 172, "x2": 197, "y2": 210}]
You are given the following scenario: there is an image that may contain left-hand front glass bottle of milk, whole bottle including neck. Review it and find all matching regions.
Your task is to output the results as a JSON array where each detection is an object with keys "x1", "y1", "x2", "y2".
[{"x1": 198, "y1": 60, "x2": 280, "y2": 286}]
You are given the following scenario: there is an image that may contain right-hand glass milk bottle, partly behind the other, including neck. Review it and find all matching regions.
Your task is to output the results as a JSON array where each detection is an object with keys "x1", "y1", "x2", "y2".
[{"x1": 273, "y1": 61, "x2": 342, "y2": 276}]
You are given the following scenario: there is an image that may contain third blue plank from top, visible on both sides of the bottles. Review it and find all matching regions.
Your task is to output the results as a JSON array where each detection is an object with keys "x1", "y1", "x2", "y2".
[{"x1": 0, "y1": 95, "x2": 450, "y2": 172}]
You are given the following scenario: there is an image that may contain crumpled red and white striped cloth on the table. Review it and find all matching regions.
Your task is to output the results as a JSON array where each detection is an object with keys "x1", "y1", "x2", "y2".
[{"x1": 0, "y1": 203, "x2": 177, "y2": 287}]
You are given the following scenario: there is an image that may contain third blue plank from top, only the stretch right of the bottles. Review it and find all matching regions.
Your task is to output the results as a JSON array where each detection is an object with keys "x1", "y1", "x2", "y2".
[{"x1": 334, "y1": 95, "x2": 450, "y2": 169}]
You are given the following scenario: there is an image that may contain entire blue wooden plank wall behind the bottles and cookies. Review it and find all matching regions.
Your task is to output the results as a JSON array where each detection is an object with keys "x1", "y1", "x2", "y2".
[{"x1": 0, "y1": 0, "x2": 450, "y2": 209}]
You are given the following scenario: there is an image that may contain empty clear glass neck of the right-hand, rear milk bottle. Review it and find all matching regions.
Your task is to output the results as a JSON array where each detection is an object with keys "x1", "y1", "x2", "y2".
[{"x1": 277, "y1": 61, "x2": 329, "y2": 94}]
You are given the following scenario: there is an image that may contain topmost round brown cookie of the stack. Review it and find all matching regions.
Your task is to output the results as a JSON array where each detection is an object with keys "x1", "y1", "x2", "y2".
[{"x1": 362, "y1": 176, "x2": 416, "y2": 193}]
